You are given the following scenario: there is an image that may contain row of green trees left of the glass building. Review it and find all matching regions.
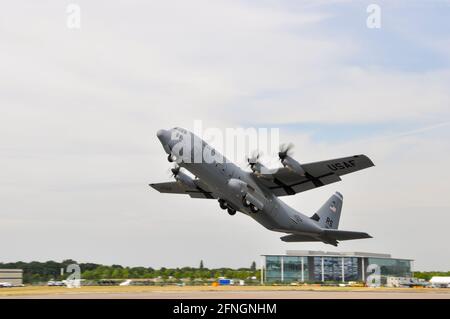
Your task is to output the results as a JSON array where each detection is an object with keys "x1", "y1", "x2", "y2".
[{"x1": 0, "y1": 259, "x2": 260, "y2": 284}]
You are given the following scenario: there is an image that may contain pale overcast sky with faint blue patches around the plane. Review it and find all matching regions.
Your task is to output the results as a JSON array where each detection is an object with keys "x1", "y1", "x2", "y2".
[{"x1": 0, "y1": 0, "x2": 450, "y2": 270}]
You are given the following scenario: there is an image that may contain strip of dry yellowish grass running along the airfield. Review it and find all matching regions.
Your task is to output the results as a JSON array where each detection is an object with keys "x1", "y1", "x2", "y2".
[{"x1": 0, "y1": 286, "x2": 450, "y2": 297}]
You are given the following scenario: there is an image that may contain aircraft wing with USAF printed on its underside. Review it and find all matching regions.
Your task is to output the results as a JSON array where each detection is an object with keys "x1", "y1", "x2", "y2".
[{"x1": 251, "y1": 155, "x2": 374, "y2": 196}]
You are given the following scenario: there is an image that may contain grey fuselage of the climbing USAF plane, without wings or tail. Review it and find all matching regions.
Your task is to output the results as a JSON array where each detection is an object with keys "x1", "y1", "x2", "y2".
[{"x1": 157, "y1": 128, "x2": 323, "y2": 236}]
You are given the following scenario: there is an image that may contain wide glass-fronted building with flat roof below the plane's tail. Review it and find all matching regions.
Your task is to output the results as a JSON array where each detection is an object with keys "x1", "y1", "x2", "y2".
[{"x1": 261, "y1": 250, "x2": 413, "y2": 284}]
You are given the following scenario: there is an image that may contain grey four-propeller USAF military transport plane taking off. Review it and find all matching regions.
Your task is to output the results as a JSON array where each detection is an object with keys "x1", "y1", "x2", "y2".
[{"x1": 150, "y1": 127, "x2": 374, "y2": 246}]
